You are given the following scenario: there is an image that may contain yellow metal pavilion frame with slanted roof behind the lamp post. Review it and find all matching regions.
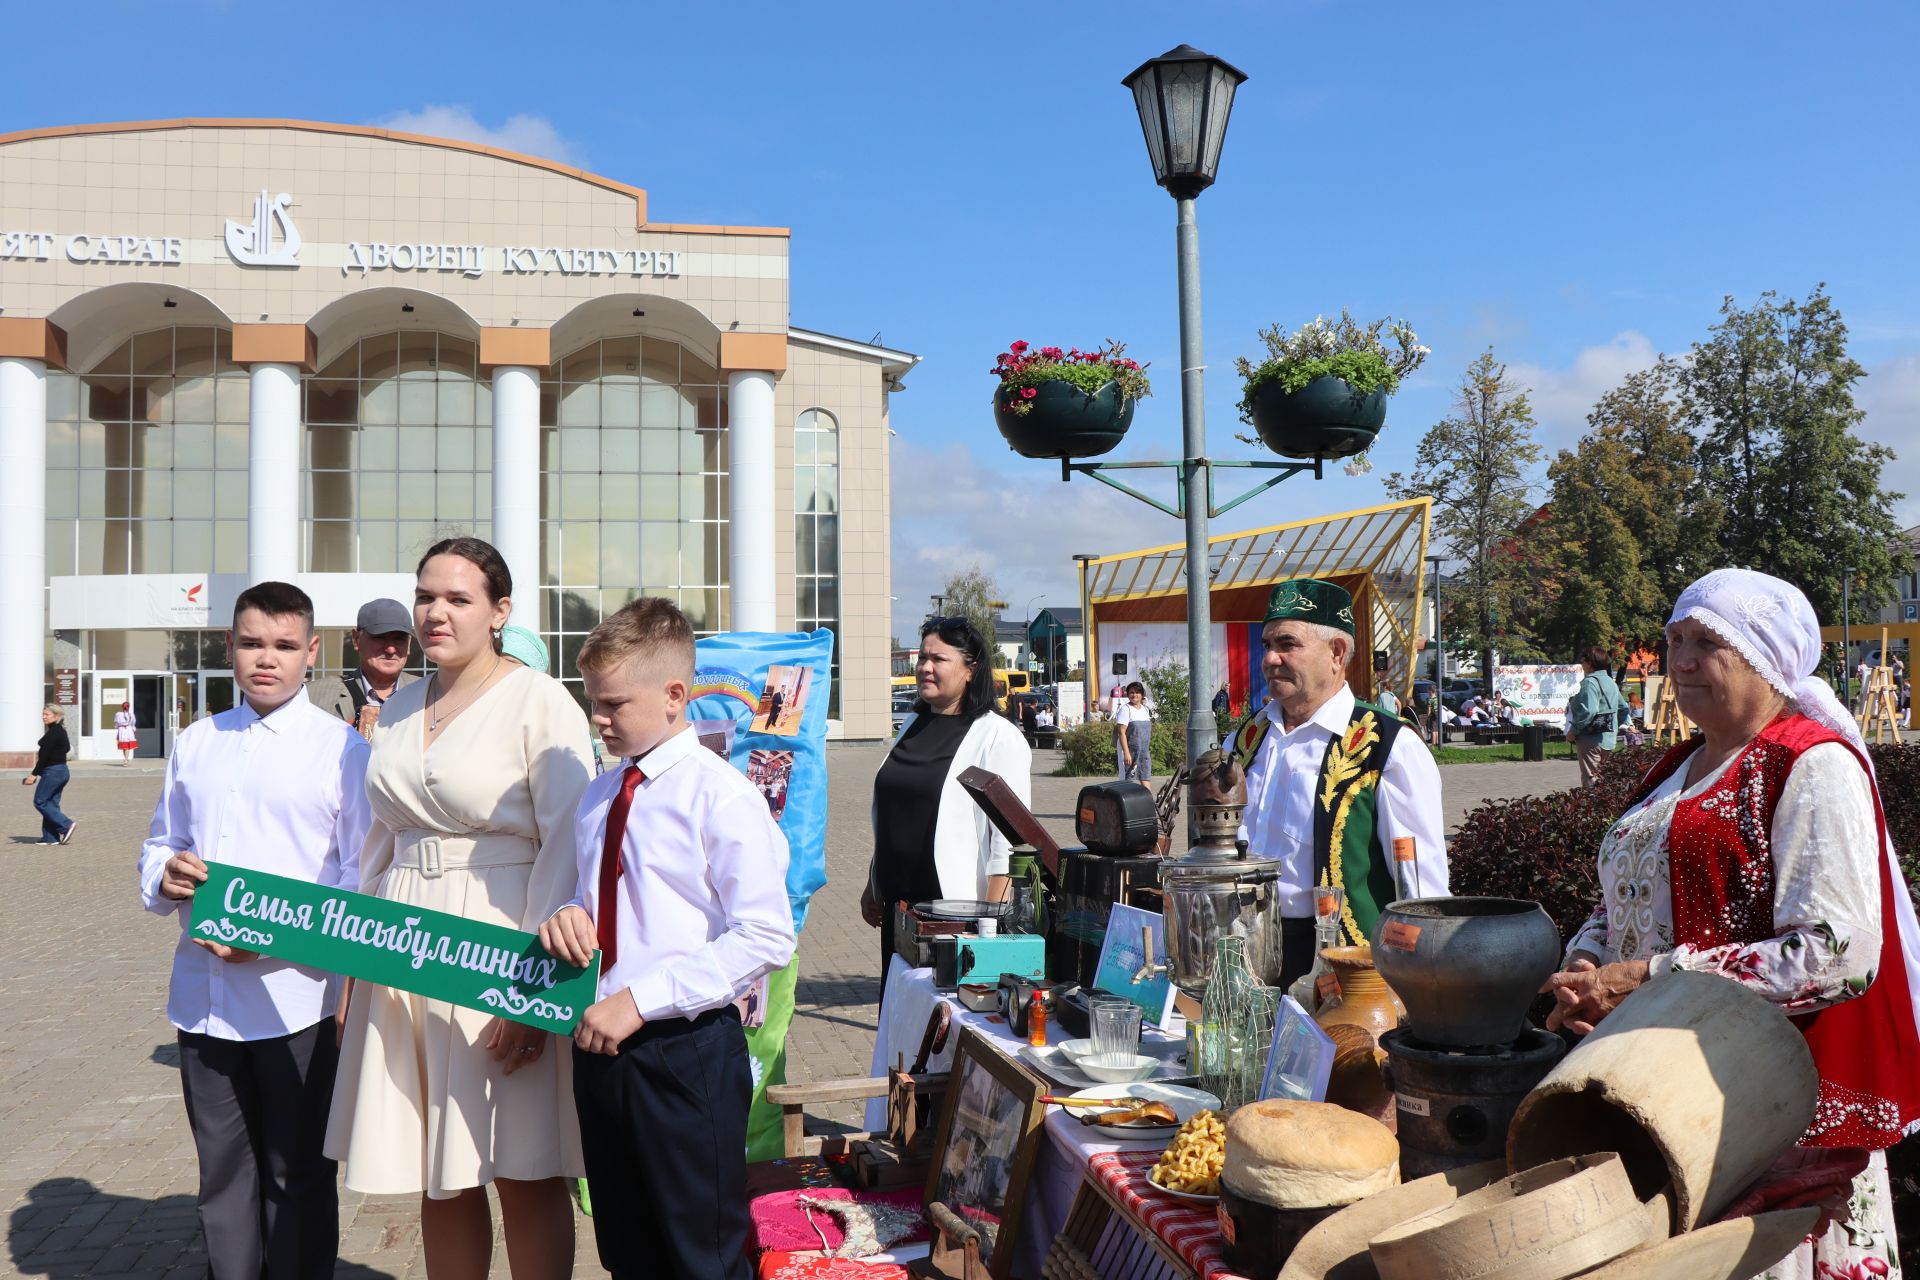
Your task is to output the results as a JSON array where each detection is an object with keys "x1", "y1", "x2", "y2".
[{"x1": 1081, "y1": 497, "x2": 1432, "y2": 699}]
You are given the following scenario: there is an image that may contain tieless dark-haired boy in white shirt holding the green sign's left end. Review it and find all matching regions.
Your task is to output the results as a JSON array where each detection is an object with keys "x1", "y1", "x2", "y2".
[{"x1": 140, "y1": 581, "x2": 369, "y2": 1280}]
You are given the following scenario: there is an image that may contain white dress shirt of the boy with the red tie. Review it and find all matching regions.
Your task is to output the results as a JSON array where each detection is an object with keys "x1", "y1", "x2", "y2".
[{"x1": 570, "y1": 725, "x2": 793, "y2": 1021}]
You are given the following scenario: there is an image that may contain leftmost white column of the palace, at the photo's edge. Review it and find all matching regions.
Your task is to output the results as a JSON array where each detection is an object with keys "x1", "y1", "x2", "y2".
[{"x1": 0, "y1": 357, "x2": 48, "y2": 766}]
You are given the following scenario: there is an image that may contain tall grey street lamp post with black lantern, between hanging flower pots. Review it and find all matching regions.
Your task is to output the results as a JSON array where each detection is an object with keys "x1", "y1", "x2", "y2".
[{"x1": 1121, "y1": 44, "x2": 1246, "y2": 764}]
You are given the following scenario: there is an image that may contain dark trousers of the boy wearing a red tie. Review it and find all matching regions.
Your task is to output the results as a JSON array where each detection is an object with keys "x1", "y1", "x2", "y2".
[{"x1": 574, "y1": 1006, "x2": 753, "y2": 1280}]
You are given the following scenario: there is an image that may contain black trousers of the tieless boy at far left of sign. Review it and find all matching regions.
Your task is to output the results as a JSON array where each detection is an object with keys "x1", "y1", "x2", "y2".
[{"x1": 179, "y1": 1017, "x2": 340, "y2": 1280}]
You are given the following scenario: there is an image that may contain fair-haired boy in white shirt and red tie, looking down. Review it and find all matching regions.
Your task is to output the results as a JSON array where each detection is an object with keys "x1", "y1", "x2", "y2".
[{"x1": 540, "y1": 599, "x2": 793, "y2": 1280}]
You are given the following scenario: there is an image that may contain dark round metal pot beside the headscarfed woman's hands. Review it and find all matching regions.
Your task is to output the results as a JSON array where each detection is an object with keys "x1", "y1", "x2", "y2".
[{"x1": 1373, "y1": 898, "x2": 1561, "y2": 1050}]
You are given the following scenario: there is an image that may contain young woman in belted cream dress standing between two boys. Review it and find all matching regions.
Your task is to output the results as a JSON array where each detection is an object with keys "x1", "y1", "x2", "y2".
[{"x1": 326, "y1": 537, "x2": 593, "y2": 1280}]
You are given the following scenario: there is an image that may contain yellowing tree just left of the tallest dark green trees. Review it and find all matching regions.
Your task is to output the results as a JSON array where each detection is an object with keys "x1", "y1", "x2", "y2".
[{"x1": 1528, "y1": 359, "x2": 1720, "y2": 658}]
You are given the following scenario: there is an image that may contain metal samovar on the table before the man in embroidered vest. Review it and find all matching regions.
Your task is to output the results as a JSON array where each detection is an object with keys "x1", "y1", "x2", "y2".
[{"x1": 1160, "y1": 747, "x2": 1281, "y2": 1000}]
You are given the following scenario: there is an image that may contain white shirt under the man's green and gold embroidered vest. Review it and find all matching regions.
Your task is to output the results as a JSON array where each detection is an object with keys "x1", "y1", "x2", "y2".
[{"x1": 1240, "y1": 685, "x2": 1448, "y2": 919}]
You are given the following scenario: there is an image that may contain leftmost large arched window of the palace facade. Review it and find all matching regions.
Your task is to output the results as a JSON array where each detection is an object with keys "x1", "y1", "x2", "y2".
[{"x1": 46, "y1": 326, "x2": 248, "y2": 578}]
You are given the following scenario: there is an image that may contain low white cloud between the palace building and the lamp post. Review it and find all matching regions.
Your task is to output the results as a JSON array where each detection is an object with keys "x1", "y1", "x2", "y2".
[{"x1": 893, "y1": 436, "x2": 1185, "y2": 639}]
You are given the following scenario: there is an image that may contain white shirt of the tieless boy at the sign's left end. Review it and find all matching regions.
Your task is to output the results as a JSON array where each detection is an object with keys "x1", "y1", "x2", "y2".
[{"x1": 140, "y1": 689, "x2": 369, "y2": 1040}]
